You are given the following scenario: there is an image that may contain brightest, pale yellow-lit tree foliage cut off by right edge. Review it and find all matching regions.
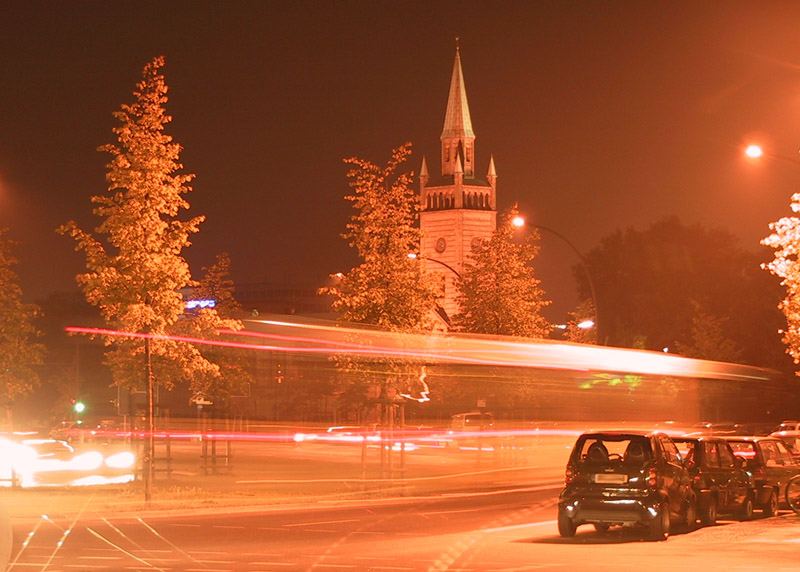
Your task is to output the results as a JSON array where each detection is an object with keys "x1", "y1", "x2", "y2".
[{"x1": 761, "y1": 193, "x2": 800, "y2": 375}]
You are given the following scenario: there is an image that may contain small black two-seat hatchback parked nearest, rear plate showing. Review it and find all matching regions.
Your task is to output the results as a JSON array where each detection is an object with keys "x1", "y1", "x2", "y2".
[{"x1": 558, "y1": 431, "x2": 697, "y2": 540}]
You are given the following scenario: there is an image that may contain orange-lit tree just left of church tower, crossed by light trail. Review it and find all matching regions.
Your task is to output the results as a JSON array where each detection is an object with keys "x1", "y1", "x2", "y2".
[{"x1": 320, "y1": 143, "x2": 438, "y2": 420}]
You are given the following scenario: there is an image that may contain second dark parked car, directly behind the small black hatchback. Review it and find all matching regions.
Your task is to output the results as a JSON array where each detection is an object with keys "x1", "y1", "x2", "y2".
[{"x1": 672, "y1": 436, "x2": 756, "y2": 525}]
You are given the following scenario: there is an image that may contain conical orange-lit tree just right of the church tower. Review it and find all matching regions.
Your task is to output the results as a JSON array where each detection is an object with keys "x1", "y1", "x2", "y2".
[{"x1": 454, "y1": 207, "x2": 550, "y2": 338}]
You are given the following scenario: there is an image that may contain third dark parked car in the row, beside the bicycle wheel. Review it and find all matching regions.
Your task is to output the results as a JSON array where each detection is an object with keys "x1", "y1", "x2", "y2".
[{"x1": 723, "y1": 436, "x2": 800, "y2": 516}]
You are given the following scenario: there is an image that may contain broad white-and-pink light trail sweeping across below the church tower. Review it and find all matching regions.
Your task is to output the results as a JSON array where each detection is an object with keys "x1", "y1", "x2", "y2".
[{"x1": 66, "y1": 320, "x2": 776, "y2": 381}]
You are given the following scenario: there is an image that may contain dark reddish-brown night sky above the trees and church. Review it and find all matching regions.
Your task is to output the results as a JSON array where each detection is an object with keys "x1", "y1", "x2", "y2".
[{"x1": 0, "y1": 0, "x2": 800, "y2": 319}]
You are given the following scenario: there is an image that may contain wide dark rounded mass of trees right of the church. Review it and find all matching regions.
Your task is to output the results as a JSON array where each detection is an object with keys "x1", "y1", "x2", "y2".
[{"x1": 575, "y1": 217, "x2": 786, "y2": 368}]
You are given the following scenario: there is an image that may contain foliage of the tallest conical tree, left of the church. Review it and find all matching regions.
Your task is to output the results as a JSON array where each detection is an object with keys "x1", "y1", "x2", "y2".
[{"x1": 59, "y1": 57, "x2": 240, "y2": 398}]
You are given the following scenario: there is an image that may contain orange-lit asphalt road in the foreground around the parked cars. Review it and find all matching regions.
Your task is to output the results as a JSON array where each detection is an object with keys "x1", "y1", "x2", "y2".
[{"x1": 9, "y1": 484, "x2": 800, "y2": 572}]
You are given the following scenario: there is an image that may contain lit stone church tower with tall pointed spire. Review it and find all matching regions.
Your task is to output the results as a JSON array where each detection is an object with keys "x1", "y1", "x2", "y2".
[{"x1": 419, "y1": 46, "x2": 497, "y2": 320}]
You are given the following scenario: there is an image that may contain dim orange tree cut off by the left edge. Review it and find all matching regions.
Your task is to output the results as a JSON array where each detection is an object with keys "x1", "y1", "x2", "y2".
[{"x1": 0, "y1": 228, "x2": 44, "y2": 428}]
